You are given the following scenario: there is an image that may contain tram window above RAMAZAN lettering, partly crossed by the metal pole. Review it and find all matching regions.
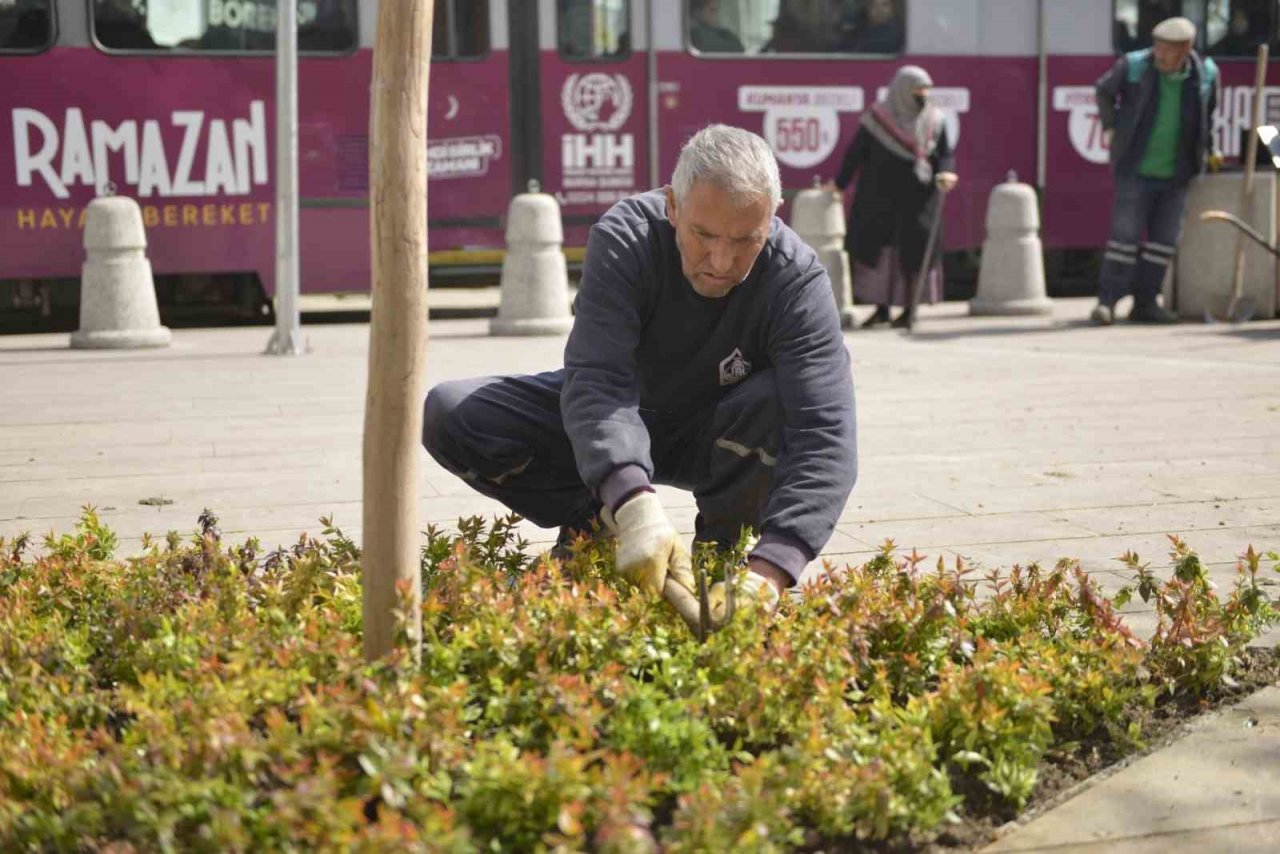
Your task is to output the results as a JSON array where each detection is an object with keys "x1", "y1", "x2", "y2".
[{"x1": 93, "y1": 0, "x2": 356, "y2": 52}]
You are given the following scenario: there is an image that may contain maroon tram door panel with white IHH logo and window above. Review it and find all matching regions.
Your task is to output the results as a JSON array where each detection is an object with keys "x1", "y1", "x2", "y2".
[{"x1": 507, "y1": 0, "x2": 650, "y2": 250}]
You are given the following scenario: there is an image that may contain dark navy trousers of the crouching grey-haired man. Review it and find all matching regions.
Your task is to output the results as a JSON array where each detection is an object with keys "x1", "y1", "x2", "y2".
[{"x1": 422, "y1": 370, "x2": 782, "y2": 544}]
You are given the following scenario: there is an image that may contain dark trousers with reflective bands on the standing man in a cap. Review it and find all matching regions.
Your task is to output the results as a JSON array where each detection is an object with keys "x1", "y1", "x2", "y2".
[{"x1": 1098, "y1": 175, "x2": 1187, "y2": 306}]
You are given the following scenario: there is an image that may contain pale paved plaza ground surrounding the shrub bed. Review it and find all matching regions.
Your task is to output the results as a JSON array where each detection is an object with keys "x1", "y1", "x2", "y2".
[{"x1": 0, "y1": 294, "x2": 1280, "y2": 851}]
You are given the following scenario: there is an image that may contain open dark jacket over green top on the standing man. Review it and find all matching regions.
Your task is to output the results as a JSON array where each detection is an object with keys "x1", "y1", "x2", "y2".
[{"x1": 1094, "y1": 47, "x2": 1221, "y2": 184}]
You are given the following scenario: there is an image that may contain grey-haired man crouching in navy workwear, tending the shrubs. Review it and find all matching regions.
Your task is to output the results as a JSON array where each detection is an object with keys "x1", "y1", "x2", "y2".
[{"x1": 422, "y1": 124, "x2": 858, "y2": 635}]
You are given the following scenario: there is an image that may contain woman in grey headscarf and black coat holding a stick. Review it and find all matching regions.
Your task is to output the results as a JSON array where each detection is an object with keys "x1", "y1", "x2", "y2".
[{"x1": 827, "y1": 65, "x2": 959, "y2": 326}]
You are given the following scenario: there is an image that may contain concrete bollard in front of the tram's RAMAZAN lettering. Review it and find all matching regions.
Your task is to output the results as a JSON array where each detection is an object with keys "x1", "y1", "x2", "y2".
[{"x1": 72, "y1": 196, "x2": 169, "y2": 350}]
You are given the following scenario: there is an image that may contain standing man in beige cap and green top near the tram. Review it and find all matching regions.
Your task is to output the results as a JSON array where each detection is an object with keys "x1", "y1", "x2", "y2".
[{"x1": 1093, "y1": 18, "x2": 1220, "y2": 326}]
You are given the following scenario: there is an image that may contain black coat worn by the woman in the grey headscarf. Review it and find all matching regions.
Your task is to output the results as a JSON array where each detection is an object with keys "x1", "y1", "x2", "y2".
[{"x1": 836, "y1": 124, "x2": 955, "y2": 275}]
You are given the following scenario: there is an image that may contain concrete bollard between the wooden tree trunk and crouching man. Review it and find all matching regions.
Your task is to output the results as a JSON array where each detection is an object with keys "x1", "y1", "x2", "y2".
[{"x1": 489, "y1": 181, "x2": 573, "y2": 335}]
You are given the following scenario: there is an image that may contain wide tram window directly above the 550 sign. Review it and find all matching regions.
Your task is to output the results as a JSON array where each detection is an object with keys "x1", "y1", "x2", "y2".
[{"x1": 689, "y1": 0, "x2": 906, "y2": 55}]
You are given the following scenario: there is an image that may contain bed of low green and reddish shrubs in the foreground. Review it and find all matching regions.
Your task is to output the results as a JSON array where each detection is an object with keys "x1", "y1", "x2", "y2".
[{"x1": 0, "y1": 510, "x2": 1277, "y2": 851}]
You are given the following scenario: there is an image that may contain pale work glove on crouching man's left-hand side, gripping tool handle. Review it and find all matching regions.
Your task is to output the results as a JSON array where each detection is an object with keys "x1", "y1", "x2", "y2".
[{"x1": 600, "y1": 492, "x2": 698, "y2": 599}]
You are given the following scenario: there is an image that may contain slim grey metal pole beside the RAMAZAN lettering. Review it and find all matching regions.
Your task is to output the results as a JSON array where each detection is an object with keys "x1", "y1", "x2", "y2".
[{"x1": 266, "y1": 0, "x2": 306, "y2": 356}]
